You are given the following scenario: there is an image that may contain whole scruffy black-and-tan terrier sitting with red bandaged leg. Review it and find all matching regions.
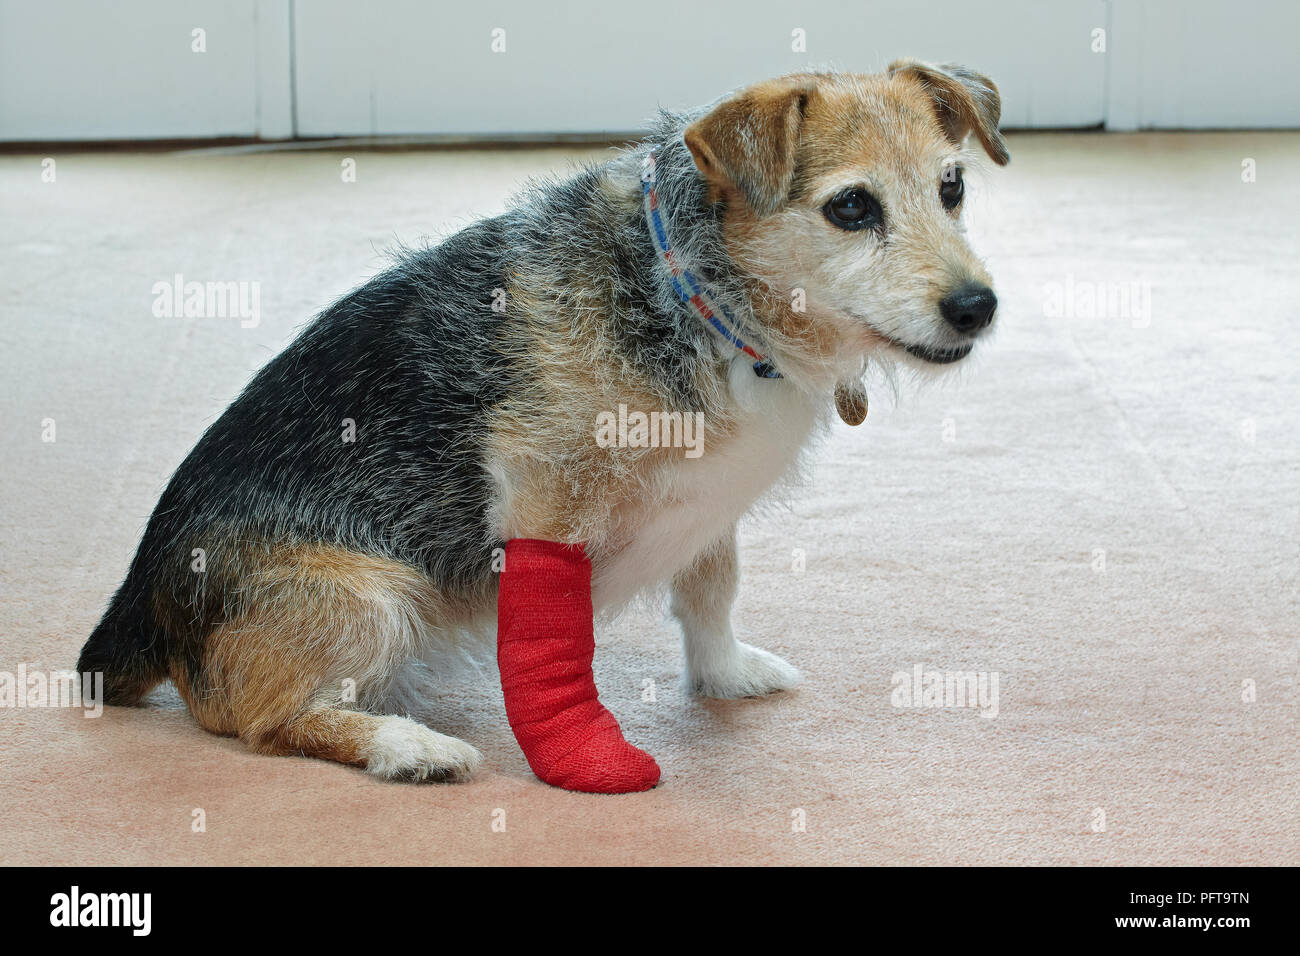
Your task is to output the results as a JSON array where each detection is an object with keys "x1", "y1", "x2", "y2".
[{"x1": 79, "y1": 60, "x2": 1008, "y2": 792}]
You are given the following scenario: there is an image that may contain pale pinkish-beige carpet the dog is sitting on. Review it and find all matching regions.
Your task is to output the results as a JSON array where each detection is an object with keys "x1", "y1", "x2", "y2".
[{"x1": 0, "y1": 133, "x2": 1300, "y2": 864}]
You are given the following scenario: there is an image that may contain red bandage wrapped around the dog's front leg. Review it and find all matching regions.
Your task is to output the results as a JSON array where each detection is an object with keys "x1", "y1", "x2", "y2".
[{"x1": 497, "y1": 538, "x2": 659, "y2": 793}]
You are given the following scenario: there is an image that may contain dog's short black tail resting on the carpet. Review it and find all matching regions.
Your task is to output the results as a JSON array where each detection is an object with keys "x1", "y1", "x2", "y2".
[{"x1": 77, "y1": 584, "x2": 168, "y2": 706}]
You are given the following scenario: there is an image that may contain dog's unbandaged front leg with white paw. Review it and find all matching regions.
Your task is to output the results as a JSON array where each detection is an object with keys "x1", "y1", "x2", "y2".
[{"x1": 672, "y1": 528, "x2": 800, "y2": 697}]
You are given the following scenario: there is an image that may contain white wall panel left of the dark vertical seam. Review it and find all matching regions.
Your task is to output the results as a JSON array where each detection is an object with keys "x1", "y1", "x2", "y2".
[{"x1": 0, "y1": 0, "x2": 293, "y2": 140}]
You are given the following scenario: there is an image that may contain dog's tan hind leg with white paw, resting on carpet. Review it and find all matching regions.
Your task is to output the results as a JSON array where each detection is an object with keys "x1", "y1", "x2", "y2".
[{"x1": 177, "y1": 546, "x2": 482, "y2": 780}]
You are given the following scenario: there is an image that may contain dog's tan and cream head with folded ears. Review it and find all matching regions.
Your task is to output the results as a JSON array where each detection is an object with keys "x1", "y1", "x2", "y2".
[{"x1": 684, "y1": 60, "x2": 1009, "y2": 365}]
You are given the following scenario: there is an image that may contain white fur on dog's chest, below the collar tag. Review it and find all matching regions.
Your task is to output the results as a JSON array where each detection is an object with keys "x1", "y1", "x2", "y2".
[{"x1": 593, "y1": 382, "x2": 818, "y2": 607}]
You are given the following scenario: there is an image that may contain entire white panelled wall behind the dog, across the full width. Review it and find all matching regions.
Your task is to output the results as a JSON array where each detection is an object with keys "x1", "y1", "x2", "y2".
[{"x1": 0, "y1": 0, "x2": 1300, "y2": 140}]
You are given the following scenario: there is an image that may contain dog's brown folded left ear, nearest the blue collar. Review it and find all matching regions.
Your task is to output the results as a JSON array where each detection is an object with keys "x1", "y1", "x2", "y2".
[{"x1": 684, "y1": 77, "x2": 816, "y2": 216}]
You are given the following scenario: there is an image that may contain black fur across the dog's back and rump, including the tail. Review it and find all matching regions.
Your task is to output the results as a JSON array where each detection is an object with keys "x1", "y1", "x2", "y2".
[{"x1": 78, "y1": 220, "x2": 516, "y2": 704}]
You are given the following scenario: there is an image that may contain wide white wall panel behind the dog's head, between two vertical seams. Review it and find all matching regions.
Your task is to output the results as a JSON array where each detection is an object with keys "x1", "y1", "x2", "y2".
[{"x1": 296, "y1": 0, "x2": 1105, "y2": 135}]
